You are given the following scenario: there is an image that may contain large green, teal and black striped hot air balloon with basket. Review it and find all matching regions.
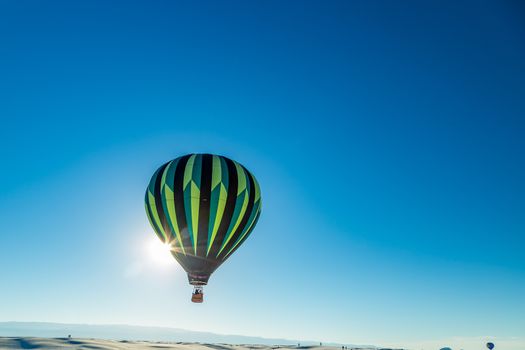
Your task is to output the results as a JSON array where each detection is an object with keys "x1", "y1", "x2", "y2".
[{"x1": 145, "y1": 154, "x2": 261, "y2": 303}]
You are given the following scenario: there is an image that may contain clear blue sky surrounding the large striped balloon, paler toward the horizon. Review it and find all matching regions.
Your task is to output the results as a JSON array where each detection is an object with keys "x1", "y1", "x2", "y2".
[{"x1": 0, "y1": 1, "x2": 525, "y2": 349}]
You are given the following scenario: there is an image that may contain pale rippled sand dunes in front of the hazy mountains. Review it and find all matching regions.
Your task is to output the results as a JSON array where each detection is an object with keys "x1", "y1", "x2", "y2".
[{"x1": 0, "y1": 337, "x2": 341, "y2": 350}]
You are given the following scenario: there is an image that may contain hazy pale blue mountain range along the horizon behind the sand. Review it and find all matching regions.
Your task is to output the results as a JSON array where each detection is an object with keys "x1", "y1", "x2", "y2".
[{"x1": 0, "y1": 322, "x2": 375, "y2": 348}]
